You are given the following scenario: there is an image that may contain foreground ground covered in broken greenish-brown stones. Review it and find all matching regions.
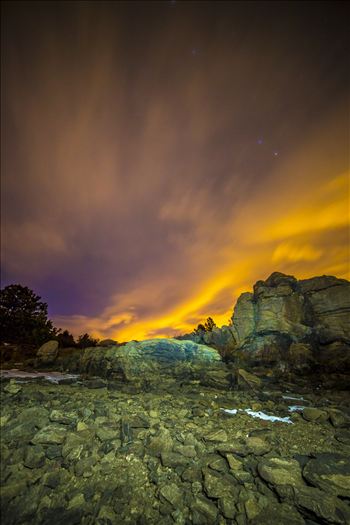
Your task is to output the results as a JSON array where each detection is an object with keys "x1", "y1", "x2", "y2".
[{"x1": 1, "y1": 378, "x2": 350, "y2": 525}]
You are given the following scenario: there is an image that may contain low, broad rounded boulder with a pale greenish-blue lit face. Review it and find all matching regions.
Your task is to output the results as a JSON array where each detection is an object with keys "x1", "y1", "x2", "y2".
[{"x1": 79, "y1": 339, "x2": 230, "y2": 388}]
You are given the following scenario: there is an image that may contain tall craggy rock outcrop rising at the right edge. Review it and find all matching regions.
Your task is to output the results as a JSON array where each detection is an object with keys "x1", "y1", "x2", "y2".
[{"x1": 231, "y1": 272, "x2": 350, "y2": 367}]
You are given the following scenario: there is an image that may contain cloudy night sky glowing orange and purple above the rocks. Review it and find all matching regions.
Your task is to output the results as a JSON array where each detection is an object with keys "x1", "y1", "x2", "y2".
[{"x1": 1, "y1": 1, "x2": 350, "y2": 341}]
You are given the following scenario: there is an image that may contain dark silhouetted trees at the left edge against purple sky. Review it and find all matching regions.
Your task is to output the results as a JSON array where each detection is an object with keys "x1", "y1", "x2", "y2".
[{"x1": 0, "y1": 284, "x2": 98, "y2": 348}]
